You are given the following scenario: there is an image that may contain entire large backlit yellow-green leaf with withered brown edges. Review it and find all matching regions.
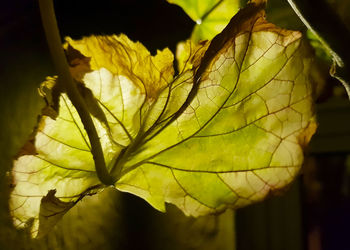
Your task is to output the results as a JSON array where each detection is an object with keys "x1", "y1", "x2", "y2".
[{"x1": 11, "y1": 3, "x2": 316, "y2": 234}]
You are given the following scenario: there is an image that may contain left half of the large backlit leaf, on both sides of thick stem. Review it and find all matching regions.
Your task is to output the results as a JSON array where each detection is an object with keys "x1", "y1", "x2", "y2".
[{"x1": 10, "y1": 35, "x2": 174, "y2": 236}]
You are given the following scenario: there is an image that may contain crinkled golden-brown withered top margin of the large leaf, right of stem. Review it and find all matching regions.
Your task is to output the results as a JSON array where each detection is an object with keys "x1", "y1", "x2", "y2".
[{"x1": 65, "y1": 35, "x2": 174, "y2": 100}]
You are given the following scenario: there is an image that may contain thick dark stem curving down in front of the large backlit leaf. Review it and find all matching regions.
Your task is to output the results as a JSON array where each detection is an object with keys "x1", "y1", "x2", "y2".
[{"x1": 39, "y1": 0, "x2": 114, "y2": 185}]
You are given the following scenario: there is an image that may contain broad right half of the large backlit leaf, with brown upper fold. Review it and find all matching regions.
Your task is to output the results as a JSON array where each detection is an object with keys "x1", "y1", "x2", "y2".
[{"x1": 116, "y1": 2, "x2": 316, "y2": 216}]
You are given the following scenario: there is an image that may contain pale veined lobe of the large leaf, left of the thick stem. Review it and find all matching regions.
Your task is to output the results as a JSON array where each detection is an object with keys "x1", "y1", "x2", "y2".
[{"x1": 10, "y1": 90, "x2": 107, "y2": 236}]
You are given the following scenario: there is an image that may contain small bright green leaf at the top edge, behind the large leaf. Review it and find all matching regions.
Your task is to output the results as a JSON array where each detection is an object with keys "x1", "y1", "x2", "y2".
[{"x1": 167, "y1": 0, "x2": 240, "y2": 42}]
